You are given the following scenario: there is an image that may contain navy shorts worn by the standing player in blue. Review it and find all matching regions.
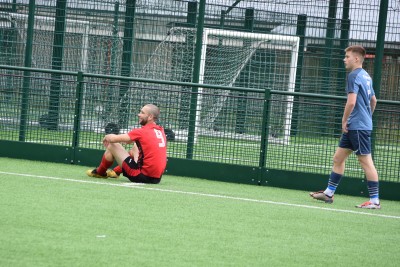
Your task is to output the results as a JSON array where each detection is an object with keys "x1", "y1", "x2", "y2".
[{"x1": 339, "y1": 130, "x2": 372, "y2": 155}]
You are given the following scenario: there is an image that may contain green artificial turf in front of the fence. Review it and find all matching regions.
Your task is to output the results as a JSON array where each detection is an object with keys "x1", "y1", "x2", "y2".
[{"x1": 0, "y1": 158, "x2": 400, "y2": 266}]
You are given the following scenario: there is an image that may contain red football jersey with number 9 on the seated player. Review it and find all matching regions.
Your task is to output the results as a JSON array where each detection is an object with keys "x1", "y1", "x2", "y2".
[{"x1": 128, "y1": 124, "x2": 167, "y2": 178}]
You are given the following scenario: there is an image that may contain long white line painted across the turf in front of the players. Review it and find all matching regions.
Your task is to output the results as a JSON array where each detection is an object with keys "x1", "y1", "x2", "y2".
[{"x1": 0, "y1": 171, "x2": 400, "y2": 219}]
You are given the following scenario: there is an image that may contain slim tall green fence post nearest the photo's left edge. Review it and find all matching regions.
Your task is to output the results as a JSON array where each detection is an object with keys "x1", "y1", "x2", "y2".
[{"x1": 19, "y1": 0, "x2": 35, "y2": 142}]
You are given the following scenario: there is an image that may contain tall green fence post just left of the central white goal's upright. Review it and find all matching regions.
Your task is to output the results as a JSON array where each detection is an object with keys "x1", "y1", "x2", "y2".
[{"x1": 186, "y1": 0, "x2": 206, "y2": 159}]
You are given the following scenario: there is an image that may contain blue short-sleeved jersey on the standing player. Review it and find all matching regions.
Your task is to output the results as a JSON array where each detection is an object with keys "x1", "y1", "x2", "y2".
[{"x1": 346, "y1": 68, "x2": 375, "y2": 131}]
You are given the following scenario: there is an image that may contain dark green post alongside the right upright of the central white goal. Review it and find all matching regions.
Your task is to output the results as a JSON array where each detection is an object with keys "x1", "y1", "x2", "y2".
[{"x1": 290, "y1": 14, "x2": 307, "y2": 135}]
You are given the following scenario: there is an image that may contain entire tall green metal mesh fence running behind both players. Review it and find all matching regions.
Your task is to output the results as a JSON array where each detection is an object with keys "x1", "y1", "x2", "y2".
[{"x1": 0, "y1": 0, "x2": 400, "y2": 199}]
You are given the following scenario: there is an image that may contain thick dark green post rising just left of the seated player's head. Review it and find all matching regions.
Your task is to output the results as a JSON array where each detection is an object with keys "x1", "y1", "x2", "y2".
[{"x1": 118, "y1": 0, "x2": 136, "y2": 128}]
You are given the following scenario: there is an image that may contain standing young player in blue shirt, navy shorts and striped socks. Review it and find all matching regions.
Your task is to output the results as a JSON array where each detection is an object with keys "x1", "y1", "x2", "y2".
[{"x1": 310, "y1": 45, "x2": 381, "y2": 209}]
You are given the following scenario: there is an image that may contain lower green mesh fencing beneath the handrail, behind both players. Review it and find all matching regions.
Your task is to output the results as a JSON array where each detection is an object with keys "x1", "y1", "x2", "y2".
[{"x1": 0, "y1": 66, "x2": 400, "y2": 182}]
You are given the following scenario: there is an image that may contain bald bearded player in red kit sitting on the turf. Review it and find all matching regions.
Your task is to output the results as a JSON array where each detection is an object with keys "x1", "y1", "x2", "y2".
[{"x1": 86, "y1": 104, "x2": 167, "y2": 184}]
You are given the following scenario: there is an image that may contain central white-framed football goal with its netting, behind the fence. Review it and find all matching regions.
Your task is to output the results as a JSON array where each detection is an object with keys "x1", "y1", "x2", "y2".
[{"x1": 137, "y1": 27, "x2": 299, "y2": 143}]
